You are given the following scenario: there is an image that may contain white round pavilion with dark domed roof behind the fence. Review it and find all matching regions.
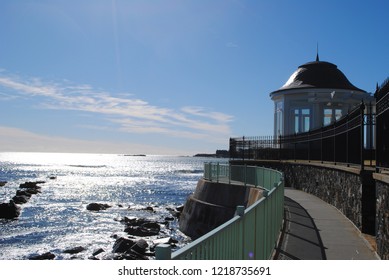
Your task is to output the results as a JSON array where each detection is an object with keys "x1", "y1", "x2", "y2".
[{"x1": 270, "y1": 56, "x2": 374, "y2": 136}]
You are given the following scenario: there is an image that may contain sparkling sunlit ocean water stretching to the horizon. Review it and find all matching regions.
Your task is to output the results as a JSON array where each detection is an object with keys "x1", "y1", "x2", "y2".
[{"x1": 0, "y1": 153, "x2": 223, "y2": 260}]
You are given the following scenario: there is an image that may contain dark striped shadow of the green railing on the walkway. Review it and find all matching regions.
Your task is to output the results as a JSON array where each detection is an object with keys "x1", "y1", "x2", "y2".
[{"x1": 274, "y1": 197, "x2": 327, "y2": 260}]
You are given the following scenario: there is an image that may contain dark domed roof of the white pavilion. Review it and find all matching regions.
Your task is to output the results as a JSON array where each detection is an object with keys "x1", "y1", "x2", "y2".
[{"x1": 272, "y1": 57, "x2": 365, "y2": 93}]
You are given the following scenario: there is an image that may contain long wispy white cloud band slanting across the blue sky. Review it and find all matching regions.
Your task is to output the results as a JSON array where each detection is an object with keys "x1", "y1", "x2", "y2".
[{"x1": 0, "y1": 72, "x2": 233, "y2": 142}]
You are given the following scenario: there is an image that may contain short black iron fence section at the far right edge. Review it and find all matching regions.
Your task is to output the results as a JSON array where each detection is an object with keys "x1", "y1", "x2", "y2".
[{"x1": 375, "y1": 79, "x2": 389, "y2": 169}]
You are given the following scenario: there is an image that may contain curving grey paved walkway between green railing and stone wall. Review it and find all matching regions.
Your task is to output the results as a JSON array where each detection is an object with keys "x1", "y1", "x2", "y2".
[{"x1": 275, "y1": 188, "x2": 379, "y2": 260}]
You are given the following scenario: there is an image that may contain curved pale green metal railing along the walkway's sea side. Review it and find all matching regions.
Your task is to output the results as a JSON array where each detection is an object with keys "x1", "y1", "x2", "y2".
[{"x1": 156, "y1": 163, "x2": 284, "y2": 260}]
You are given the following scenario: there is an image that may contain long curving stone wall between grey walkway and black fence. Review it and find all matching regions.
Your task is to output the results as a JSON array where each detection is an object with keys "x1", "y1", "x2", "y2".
[{"x1": 232, "y1": 161, "x2": 375, "y2": 234}]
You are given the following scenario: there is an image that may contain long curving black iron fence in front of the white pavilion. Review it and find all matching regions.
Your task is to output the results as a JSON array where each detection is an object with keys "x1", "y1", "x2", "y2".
[{"x1": 230, "y1": 103, "x2": 374, "y2": 169}]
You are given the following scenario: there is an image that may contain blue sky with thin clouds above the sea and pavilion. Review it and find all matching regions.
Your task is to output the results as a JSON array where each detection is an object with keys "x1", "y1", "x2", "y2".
[{"x1": 0, "y1": 0, "x2": 389, "y2": 155}]
